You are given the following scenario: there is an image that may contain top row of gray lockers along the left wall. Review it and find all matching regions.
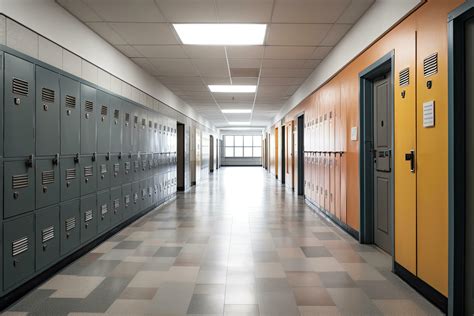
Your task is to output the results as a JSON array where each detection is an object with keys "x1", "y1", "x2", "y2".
[{"x1": 0, "y1": 52, "x2": 176, "y2": 157}]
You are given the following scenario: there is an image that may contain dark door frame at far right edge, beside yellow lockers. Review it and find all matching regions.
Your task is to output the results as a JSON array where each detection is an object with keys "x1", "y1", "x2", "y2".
[{"x1": 448, "y1": 0, "x2": 474, "y2": 315}]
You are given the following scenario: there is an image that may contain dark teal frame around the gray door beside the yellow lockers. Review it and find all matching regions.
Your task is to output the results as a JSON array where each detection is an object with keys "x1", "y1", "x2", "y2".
[{"x1": 359, "y1": 50, "x2": 395, "y2": 258}]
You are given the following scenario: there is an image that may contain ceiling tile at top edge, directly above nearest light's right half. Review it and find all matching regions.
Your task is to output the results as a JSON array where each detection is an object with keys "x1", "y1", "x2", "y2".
[{"x1": 217, "y1": 0, "x2": 273, "y2": 23}]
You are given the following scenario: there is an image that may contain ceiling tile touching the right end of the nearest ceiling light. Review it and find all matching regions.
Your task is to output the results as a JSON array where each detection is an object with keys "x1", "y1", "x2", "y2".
[{"x1": 266, "y1": 24, "x2": 331, "y2": 46}]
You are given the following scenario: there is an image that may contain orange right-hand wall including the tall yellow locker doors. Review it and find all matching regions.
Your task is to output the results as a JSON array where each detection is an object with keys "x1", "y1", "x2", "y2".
[{"x1": 271, "y1": 0, "x2": 462, "y2": 296}]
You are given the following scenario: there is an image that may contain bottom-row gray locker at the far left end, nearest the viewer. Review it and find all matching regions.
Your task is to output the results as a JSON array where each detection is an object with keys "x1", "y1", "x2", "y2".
[{"x1": 3, "y1": 214, "x2": 35, "y2": 290}]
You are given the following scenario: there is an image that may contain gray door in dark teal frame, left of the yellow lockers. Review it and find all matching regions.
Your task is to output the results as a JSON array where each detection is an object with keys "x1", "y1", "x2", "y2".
[{"x1": 374, "y1": 74, "x2": 393, "y2": 253}]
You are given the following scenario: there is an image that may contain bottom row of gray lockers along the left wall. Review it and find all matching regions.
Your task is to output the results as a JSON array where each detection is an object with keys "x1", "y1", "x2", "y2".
[{"x1": 3, "y1": 172, "x2": 176, "y2": 292}]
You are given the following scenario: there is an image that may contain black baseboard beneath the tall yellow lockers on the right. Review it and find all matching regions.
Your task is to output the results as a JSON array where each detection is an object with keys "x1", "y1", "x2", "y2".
[{"x1": 393, "y1": 262, "x2": 448, "y2": 314}]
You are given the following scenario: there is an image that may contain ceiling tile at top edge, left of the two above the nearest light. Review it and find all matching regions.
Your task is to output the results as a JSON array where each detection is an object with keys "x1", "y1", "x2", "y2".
[{"x1": 82, "y1": 0, "x2": 164, "y2": 22}]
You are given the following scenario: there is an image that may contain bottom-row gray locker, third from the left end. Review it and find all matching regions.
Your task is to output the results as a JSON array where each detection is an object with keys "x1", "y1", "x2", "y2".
[{"x1": 60, "y1": 199, "x2": 81, "y2": 255}]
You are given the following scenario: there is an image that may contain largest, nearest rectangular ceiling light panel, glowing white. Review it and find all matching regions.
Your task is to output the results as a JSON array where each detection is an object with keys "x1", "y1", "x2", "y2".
[{"x1": 173, "y1": 23, "x2": 267, "y2": 45}]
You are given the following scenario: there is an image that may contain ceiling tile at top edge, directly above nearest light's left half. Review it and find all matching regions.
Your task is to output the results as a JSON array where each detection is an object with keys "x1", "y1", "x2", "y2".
[{"x1": 155, "y1": 0, "x2": 218, "y2": 23}]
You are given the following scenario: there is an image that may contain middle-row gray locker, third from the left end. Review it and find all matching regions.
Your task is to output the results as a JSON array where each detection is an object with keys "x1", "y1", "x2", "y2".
[{"x1": 59, "y1": 154, "x2": 81, "y2": 201}]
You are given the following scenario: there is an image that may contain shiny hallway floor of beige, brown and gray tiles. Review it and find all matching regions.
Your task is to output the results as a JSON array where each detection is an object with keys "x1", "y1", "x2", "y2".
[{"x1": 6, "y1": 167, "x2": 440, "y2": 316}]
